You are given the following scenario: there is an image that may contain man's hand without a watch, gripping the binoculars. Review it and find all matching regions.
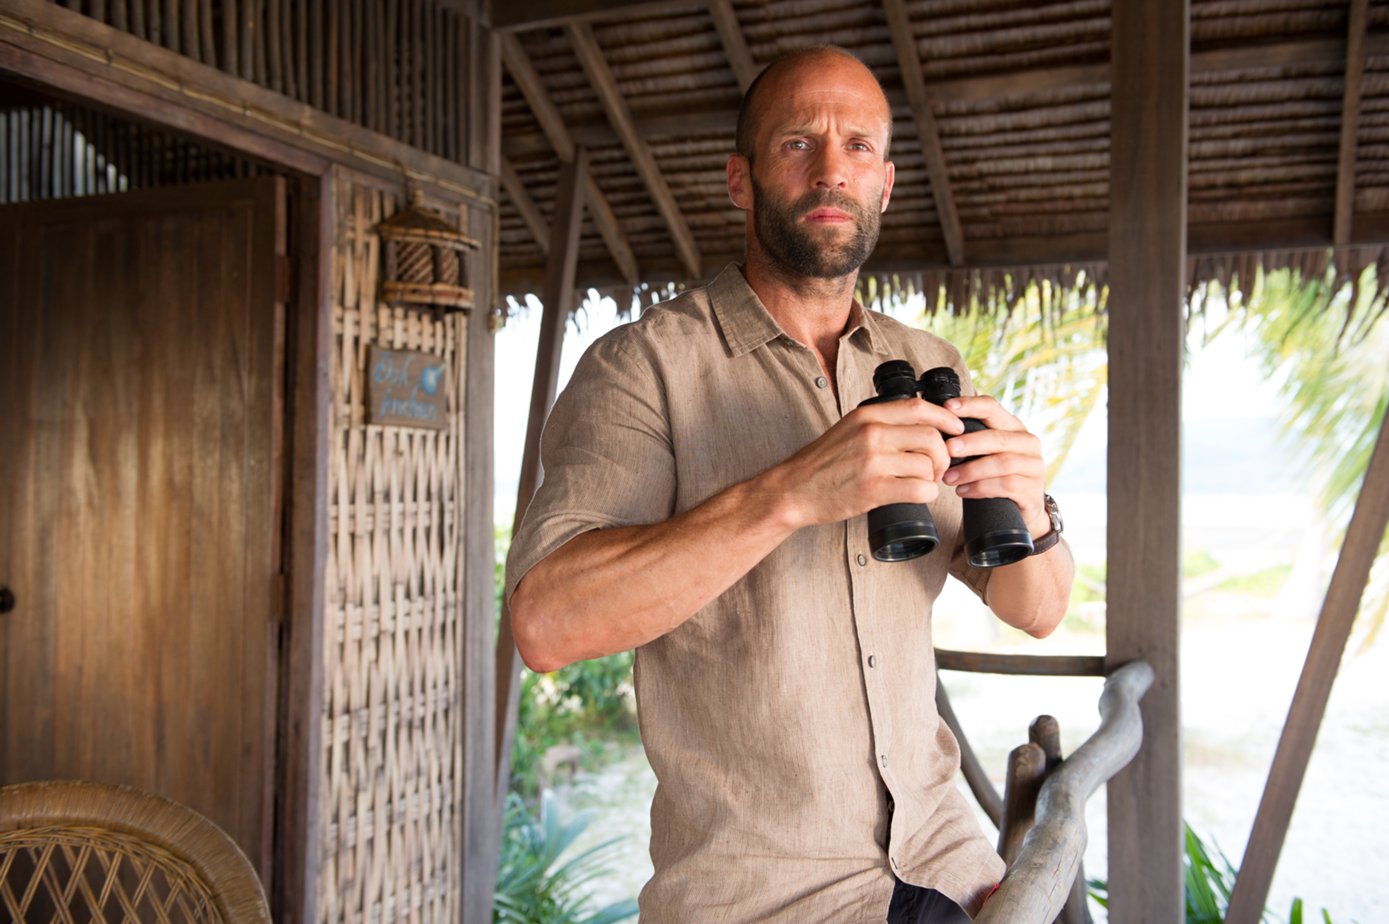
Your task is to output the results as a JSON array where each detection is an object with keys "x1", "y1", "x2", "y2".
[{"x1": 754, "y1": 399, "x2": 966, "y2": 528}]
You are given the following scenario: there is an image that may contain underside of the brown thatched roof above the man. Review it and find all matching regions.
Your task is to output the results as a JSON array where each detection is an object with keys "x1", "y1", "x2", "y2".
[{"x1": 493, "y1": 0, "x2": 1389, "y2": 316}]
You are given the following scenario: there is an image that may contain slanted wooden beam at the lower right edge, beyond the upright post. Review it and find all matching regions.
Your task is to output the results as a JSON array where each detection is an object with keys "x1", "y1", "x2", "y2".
[{"x1": 1225, "y1": 415, "x2": 1389, "y2": 924}]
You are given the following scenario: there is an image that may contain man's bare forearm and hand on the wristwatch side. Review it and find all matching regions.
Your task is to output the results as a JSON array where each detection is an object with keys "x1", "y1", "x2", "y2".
[{"x1": 942, "y1": 396, "x2": 1075, "y2": 638}]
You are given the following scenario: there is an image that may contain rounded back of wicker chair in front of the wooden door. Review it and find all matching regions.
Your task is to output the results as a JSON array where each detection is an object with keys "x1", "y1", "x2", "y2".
[{"x1": 0, "y1": 782, "x2": 271, "y2": 924}]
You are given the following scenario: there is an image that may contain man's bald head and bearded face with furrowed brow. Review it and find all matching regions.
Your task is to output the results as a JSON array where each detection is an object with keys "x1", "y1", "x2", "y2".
[{"x1": 729, "y1": 54, "x2": 893, "y2": 279}]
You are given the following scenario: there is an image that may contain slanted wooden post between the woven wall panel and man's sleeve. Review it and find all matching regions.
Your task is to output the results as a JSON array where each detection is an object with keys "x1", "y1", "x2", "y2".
[{"x1": 494, "y1": 147, "x2": 589, "y2": 811}]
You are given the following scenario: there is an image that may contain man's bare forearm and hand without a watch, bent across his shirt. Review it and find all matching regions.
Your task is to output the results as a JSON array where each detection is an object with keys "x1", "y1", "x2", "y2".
[{"x1": 510, "y1": 402, "x2": 963, "y2": 671}]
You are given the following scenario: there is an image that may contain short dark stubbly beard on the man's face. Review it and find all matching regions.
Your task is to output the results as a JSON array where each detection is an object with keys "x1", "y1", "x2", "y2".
[{"x1": 753, "y1": 178, "x2": 882, "y2": 279}]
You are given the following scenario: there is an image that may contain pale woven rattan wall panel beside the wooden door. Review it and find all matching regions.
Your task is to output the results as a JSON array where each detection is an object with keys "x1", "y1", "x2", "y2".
[{"x1": 318, "y1": 175, "x2": 467, "y2": 923}]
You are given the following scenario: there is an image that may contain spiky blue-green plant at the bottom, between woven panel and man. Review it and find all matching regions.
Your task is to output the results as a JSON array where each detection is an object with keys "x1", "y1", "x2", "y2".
[{"x1": 492, "y1": 793, "x2": 638, "y2": 924}]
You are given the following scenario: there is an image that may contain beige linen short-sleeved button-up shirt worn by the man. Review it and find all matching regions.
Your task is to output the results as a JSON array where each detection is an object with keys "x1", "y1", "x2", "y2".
[{"x1": 507, "y1": 265, "x2": 1003, "y2": 924}]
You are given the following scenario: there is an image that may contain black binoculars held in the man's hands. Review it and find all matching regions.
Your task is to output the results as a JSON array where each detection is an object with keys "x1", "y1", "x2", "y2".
[{"x1": 863, "y1": 360, "x2": 1032, "y2": 568}]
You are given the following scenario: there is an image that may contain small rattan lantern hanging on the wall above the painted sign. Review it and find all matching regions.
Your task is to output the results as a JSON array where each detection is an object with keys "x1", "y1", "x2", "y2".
[{"x1": 376, "y1": 189, "x2": 478, "y2": 311}]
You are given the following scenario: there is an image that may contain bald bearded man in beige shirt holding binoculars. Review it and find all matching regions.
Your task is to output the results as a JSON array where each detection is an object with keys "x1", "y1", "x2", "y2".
[{"x1": 507, "y1": 47, "x2": 1074, "y2": 924}]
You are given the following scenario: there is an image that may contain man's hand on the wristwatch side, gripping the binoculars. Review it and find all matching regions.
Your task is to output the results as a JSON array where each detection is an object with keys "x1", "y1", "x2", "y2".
[{"x1": 940, "y1": 395, "x2": 1051, "y2": 536}]
